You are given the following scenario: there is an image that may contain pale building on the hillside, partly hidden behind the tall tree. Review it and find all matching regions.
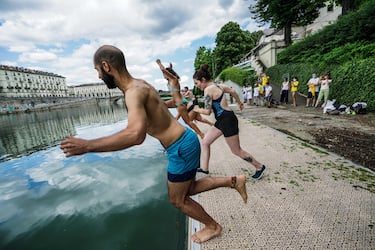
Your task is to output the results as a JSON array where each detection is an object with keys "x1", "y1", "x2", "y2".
[{"x1": 234, "y1": 2, "x2": 342, "y2": 75}]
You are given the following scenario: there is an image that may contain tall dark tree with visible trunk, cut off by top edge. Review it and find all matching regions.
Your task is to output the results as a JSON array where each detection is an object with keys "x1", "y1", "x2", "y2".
[{"x1": 249, "y1": 0, "x2": 326, "y2": 46}]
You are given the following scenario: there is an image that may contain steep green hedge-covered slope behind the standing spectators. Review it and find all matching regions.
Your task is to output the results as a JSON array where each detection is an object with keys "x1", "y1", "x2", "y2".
[{"x1": 266, "y1": 1, "x2": 375, "y2": 111}]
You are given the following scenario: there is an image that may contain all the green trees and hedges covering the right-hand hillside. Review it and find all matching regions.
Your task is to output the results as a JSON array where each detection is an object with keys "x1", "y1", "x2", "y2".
[{"x1": 194, "y1": 0, "x2": 375, "y2": 111}]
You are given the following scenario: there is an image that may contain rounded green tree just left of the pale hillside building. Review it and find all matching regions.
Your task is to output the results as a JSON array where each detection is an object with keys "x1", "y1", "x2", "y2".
[{"x1": 212, "y1": 22, "x2": 257, "y2": 77}]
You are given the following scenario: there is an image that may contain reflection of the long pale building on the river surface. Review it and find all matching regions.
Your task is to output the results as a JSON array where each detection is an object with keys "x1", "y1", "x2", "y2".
[{"x1": 0, "y1": 102, "x2": 126, "y2": 161}]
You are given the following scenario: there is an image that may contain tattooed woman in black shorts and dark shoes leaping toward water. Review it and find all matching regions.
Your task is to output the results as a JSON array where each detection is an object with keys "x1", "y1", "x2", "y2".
[{"x1": 193, "y1": 64, "x2": 266, "y2": 180}]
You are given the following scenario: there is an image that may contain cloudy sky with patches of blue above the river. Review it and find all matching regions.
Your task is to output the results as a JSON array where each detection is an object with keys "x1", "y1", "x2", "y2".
[{"x1": 0, "y1": 0, "x2": 260, "y2": 89}]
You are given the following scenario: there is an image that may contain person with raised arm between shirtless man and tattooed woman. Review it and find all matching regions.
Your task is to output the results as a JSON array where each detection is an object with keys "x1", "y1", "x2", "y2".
[{"x1": 156, "y1": 59, "x2": 204, "y2": 139}]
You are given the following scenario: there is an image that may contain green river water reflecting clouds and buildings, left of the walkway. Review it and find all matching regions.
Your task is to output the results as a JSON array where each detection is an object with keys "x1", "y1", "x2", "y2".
[{"x1": 0, "y1": 102, "x2": 187, "y2": 250}]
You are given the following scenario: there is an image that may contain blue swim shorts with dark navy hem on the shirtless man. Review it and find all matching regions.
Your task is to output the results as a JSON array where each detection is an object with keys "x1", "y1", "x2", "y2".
[{"x1": 166, "y1": 128, "x2": 201, "y2": 182}]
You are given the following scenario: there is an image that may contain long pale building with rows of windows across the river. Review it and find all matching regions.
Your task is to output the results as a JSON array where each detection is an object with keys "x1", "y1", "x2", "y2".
[{"x1": 0, "y1": 65, "x2": 123, "y2": 114}]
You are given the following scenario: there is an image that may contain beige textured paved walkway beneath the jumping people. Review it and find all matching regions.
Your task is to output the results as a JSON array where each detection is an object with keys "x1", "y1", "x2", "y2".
[{"x1": 190, "y1": 108, "x2": 375, "y2": 250}]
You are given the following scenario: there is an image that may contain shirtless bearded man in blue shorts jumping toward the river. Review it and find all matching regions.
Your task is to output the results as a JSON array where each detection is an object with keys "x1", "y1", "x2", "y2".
[{"x1": 60, "y1": 45, "x2": 247, "y2": 243}]
